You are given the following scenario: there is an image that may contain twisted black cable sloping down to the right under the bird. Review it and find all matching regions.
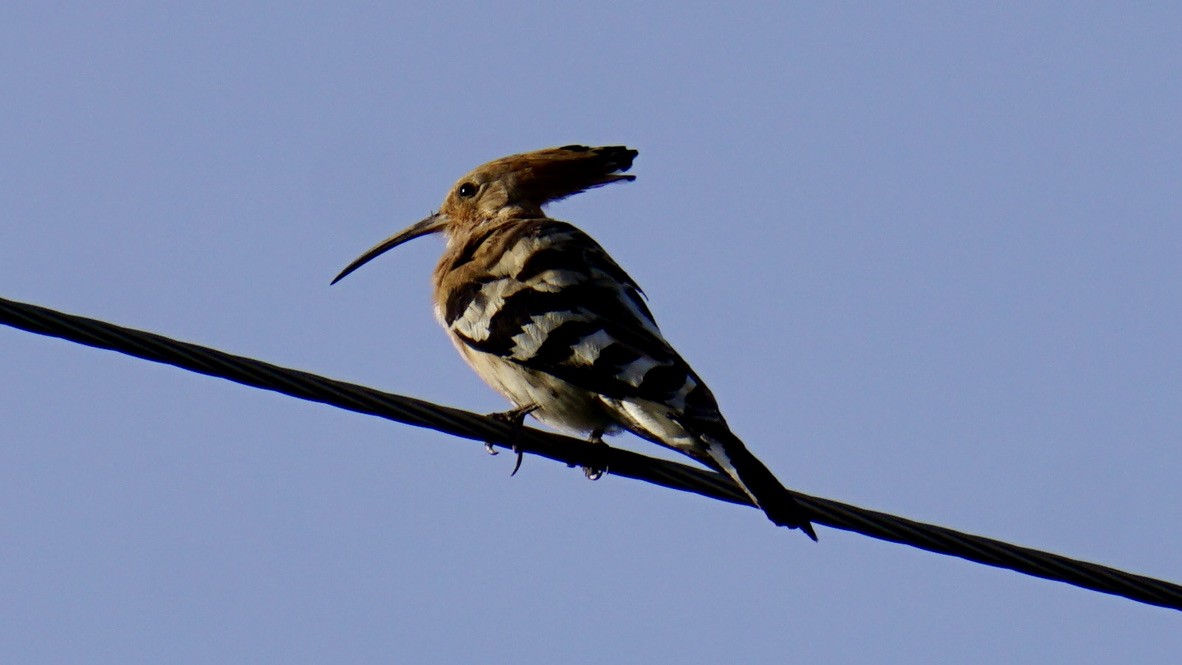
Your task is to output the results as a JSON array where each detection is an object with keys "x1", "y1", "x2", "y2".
[{"x1": 0, "y1": 299, "x2": 1182, "y2": 609}]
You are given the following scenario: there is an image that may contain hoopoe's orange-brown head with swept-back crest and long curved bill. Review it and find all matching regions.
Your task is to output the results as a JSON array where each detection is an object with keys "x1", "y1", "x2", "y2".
[{"x1": 332, "y1": 145, "x2": 637, "y2": 283}]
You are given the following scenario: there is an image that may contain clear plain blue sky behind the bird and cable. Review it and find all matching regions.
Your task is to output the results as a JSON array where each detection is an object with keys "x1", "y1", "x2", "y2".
[{"x1": 0, "y1": 2, "x2": 1182, "y2": 664}]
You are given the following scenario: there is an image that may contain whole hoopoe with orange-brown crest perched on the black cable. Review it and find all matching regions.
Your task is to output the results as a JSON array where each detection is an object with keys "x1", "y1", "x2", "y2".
[{"x1": 332, "y1": 145, "x2": 817, "y2": 540}]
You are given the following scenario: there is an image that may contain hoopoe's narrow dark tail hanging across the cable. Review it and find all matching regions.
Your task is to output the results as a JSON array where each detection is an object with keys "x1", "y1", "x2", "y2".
[{"x1": 702, "y1": 431, "x2": 817, "y2": 541}]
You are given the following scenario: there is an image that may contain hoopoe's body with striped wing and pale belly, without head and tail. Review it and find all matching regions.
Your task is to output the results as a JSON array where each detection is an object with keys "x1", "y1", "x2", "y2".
[{"x1": 435, "y1": 217, "x2": 725, "y2": 467}]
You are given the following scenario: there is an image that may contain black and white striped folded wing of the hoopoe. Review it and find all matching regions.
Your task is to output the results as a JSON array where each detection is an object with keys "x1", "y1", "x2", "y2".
[{"x1": 444, "y1": 220, "x2": 719, "y2": 420}]
